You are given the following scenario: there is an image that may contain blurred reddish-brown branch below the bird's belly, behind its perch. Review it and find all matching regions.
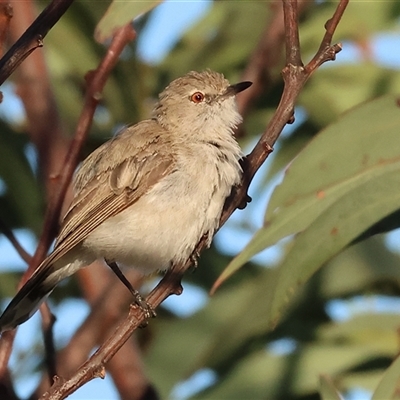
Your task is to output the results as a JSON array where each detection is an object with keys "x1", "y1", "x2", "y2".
[{"x1": 31, "y1": 262, "x2": 154, "y2": 400}]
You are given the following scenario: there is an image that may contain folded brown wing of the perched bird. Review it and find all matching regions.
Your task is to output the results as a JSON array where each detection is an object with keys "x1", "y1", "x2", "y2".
[{"x1": 40, "y1": 120, "x2": 175, "y2": 269}]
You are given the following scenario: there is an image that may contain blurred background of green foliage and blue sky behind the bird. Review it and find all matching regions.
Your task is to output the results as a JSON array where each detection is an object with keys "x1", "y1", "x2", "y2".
[{"x1": 0, "y1": 0, "x2": 400, "y2": 400}]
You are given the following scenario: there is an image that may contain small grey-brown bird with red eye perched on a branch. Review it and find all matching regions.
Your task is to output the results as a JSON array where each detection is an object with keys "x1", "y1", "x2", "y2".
[{"x1": 0, "y1": 70, "x2": 251, "y2": 332}]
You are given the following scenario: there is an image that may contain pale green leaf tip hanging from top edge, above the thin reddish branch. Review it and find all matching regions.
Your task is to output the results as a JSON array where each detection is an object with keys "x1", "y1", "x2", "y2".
[{"x1": 94, "y1": 0, "x2": 162, "y2": 43}]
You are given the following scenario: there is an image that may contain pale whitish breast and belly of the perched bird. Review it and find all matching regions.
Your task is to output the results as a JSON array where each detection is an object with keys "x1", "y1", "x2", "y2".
[{"x1": 83, "y1": 138, "x2": 241, "y2": 274}]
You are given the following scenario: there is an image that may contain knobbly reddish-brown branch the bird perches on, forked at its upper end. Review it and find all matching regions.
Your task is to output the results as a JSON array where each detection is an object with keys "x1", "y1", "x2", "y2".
[{"x1": 43, "y1": 0, "x2": 348, "y2": 400}]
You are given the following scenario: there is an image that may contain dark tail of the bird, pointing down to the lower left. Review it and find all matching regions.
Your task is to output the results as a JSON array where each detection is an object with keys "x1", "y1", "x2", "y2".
[{"x1": 0, "y1": 260, "x2": 87, "y2": 332}]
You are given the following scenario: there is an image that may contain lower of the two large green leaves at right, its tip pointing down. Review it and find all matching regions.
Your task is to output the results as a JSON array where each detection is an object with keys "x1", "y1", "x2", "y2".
[{"x1": 270, "y1": 167, "x2": 400, "y2": 324}]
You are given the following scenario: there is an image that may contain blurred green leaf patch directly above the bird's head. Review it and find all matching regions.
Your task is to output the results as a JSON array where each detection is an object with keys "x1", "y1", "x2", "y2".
[{"x1": 162, "y1": 1, "x2": 271, "y2": 78}]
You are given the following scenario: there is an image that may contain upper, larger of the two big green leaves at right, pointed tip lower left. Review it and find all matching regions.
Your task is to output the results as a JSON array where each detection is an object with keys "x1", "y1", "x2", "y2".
[{"x1": 216, "y1": 95, "x2": 400, "y2": 285}]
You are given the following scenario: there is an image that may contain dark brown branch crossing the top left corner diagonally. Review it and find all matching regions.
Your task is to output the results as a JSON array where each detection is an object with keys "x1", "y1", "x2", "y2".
[{"x1": 0, "y1": 0, "x2": 74, "y2": 85}]
